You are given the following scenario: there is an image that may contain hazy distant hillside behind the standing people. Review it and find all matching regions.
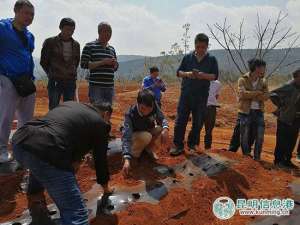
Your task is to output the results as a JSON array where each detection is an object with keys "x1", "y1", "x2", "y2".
[{"x1": 34, "y1": 48, "x2": 300, "y2": 79}]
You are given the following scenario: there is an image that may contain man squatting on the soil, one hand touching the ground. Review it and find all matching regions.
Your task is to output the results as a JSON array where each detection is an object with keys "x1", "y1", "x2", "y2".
[{"x1": 122, "y1": 89, "x2": 169, "y2": 176}]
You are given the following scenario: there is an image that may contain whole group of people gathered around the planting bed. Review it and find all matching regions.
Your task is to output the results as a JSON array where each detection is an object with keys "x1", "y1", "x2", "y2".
[{"x1": 0, "y1": 0, "x2": 300, "y2": 225}]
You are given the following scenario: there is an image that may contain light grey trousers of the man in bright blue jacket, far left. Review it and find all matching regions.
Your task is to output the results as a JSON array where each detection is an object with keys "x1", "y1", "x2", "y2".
[{"x1": 0, "y1": 75, "x2": 35, "y2": 154}]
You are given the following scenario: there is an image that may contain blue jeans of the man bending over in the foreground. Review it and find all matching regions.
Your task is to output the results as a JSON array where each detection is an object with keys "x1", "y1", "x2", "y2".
[{"x1": 13, "y1": 145, "x2": 89, "y2": 225}]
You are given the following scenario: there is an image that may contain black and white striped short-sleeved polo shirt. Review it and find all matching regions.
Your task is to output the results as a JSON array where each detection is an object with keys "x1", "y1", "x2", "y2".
[{"x1": 81, "y1": 40, "x2": 117, "y2": 88}]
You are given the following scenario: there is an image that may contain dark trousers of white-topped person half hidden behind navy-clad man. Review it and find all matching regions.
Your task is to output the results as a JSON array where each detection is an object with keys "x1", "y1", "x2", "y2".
[{"x1": 204, "y1": 105, "x2": 217, "y2": 149}]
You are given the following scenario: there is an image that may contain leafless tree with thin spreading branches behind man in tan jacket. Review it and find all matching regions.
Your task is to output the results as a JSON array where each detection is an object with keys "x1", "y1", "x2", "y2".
[{"x1": 207, "y1": 12, "x2": 300, "y2": 79}]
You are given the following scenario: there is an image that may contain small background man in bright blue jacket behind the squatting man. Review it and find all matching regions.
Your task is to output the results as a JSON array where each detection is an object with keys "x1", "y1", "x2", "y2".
[{"x1": 142, "y1": 66, "x2": 167, "y2": 108}]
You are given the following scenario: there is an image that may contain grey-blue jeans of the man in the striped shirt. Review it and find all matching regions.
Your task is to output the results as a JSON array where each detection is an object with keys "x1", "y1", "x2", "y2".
[{"x1": 89, "y1": 84, "x2": 115, "y2": 104}]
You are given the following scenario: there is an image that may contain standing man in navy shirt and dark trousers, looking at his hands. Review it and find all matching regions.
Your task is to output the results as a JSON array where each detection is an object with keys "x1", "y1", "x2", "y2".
[{"x1": 170, "y1": 33, "x2": 219, "y2": 156}]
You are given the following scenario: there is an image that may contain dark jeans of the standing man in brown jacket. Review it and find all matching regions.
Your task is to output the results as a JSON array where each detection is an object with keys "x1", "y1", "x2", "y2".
[{"x1": 48, "y1": 79, "x2": 76, "y2": 110}]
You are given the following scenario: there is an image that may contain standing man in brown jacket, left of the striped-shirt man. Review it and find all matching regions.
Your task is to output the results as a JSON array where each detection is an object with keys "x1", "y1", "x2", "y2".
[{"x1": 40, "y1": 18, "x2": 80, "y2": 110}]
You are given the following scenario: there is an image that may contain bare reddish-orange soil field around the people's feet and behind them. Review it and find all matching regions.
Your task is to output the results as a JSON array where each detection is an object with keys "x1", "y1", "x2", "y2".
[{"x1": 0, "y1": 83, "x2": 295, "y2": 225}]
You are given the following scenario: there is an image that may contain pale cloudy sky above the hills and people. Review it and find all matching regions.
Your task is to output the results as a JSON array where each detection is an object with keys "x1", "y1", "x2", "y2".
[{"x1": 0, "y1": 0, "x2": 300, "y2": 57}]
